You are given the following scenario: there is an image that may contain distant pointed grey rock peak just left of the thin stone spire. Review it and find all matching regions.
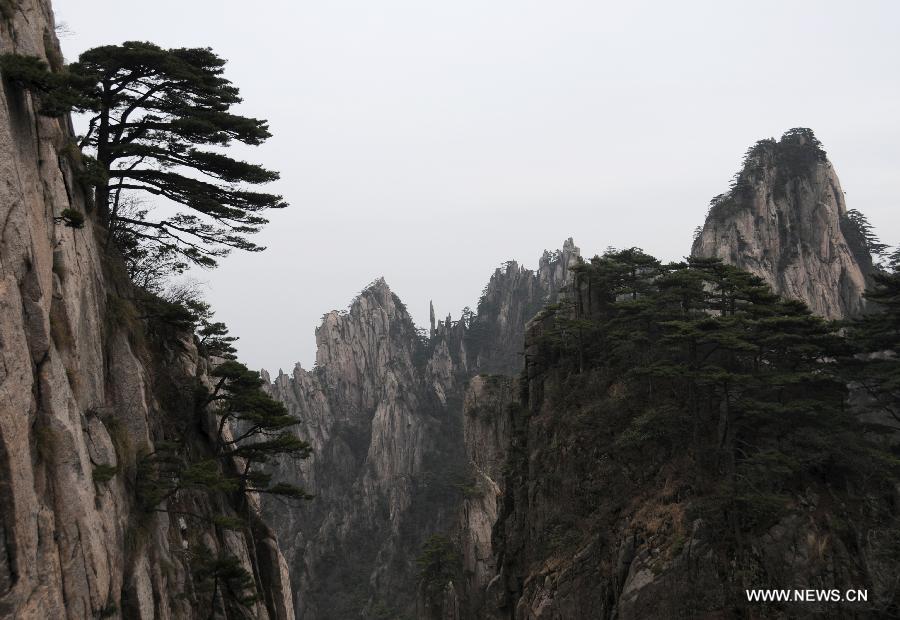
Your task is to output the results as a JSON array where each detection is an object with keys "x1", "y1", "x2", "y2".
[{"x1": 258, "y1": 280, "x2": 462, "y2": 618}]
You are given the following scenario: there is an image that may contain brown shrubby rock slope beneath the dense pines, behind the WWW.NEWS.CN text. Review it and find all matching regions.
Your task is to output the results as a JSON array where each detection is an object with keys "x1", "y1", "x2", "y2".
[{"x1": 492, "y1": 284, "x2": 897, "y2": 620}]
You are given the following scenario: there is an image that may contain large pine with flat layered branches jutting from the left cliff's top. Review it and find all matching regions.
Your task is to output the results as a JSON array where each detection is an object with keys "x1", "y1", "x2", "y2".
[{"x1": 0, "y1": 41, "x2": 287, "y2": 267}]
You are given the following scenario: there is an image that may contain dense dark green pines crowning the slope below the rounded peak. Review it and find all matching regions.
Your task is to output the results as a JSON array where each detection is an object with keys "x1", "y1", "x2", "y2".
[{"x1": 538, "y1": 248, "x2": 900, "y2": 532}]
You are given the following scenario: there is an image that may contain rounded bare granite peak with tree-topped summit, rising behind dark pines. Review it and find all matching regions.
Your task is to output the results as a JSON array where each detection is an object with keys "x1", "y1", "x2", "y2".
[{"x1": 691, "y1": 130, "x2": 872, "y2": 319}]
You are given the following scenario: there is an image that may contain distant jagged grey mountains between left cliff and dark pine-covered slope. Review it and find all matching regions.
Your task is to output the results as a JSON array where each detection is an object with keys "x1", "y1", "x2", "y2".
[{"x1": 264, "y1": 239, "x2": 578, "y2": 618}]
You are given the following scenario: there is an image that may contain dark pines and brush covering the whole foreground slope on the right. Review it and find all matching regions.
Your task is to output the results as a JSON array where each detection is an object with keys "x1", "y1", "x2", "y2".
[{"x1": 498, "y1": 248, "x2": 900, "y2": 615}]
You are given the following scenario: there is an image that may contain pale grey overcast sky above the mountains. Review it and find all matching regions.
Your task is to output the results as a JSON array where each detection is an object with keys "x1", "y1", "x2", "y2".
[{"x1": 54, "y1": 0, "x2": 900, "y2": 370}]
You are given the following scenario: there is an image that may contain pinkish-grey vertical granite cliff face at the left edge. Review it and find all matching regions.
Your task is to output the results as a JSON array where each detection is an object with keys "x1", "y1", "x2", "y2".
[{"x1": 0, "y1": 0, "x2": 293, "y2": 620}]
